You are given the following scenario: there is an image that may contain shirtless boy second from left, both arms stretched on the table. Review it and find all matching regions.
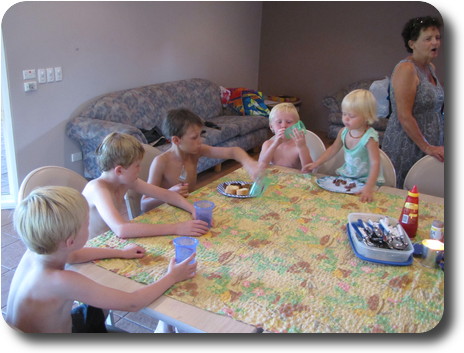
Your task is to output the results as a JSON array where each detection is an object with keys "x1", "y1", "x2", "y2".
[{"x1": 82, "y1": 132, "x2": 208, "y2": 238}]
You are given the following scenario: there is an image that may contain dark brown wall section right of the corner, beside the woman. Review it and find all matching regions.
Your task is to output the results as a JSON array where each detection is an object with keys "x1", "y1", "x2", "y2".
[{"x1": 259, "y1": 1, "x2": 446, "y2": 131}]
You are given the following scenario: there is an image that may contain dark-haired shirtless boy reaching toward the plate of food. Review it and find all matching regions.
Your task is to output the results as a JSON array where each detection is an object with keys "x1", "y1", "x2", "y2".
[{"x1": 141, "y1": 109, "x2": 260, "y2": 212}]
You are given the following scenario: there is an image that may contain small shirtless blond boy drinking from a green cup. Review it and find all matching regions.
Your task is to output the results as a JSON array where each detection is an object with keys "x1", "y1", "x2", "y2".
[{"x1": 259, "y1": 103, "x2": 312, "y2": 169}]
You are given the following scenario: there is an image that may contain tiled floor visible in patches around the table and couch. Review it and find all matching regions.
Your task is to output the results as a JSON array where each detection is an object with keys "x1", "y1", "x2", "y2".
[{"x1": 1, "y1": 133, "x2": 331, "y2": 333}]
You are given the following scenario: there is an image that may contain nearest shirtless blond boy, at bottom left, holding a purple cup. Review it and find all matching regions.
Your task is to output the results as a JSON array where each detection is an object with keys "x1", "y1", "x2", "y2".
[{"x1": 5, "y1": 186, "x2": 196, "y2": 333}]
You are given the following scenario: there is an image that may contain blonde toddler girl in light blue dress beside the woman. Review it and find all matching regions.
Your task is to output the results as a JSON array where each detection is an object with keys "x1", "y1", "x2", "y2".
[{"x1": 302, "y1": 89, "x2": 385, "y2": 202}]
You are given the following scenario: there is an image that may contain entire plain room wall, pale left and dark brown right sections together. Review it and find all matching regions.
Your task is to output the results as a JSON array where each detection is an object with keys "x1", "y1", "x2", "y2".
[{"x1": 2, "y1": 1, "x2": 446, "y2": 186}]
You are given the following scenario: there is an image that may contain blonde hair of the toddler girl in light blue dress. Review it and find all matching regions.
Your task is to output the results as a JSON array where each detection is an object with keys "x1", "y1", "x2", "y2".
[{"x1": 342, "y1": 89, "x2": 377, "y2": 125}]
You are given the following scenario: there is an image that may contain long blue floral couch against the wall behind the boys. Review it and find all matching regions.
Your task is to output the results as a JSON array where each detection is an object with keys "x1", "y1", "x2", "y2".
[{"x1": 66, "y1": 78, "x2": 269, "y2": 179}]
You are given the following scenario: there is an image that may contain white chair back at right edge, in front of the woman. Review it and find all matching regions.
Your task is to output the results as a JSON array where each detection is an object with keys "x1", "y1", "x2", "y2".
[{"x1": 403, "y1": 156, "x2": 445, "y2": 197}]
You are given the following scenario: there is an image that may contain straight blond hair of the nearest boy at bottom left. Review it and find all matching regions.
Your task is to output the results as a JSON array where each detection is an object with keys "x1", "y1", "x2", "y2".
[{"x1": 14, "y1": 186, "x2": 89, "y2": 254}]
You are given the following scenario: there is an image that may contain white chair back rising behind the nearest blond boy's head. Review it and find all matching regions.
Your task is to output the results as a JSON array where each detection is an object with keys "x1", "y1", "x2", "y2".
[{"x1": 18, "y1": 166, "x2": 87, "y2": 202}]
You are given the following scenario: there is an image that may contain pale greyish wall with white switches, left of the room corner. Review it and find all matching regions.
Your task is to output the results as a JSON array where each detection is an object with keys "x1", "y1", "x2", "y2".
[{"x1": 2, "y1": 2, "x2": 262, "y2": 183}]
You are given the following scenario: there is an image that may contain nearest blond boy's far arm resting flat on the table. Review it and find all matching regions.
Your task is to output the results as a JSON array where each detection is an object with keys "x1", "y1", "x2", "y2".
[{"x1": 66, "y1": 244, "x2": 145, "y2": 264}]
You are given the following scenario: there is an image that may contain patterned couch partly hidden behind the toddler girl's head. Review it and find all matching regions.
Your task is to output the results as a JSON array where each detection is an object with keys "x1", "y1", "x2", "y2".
[{"x1": 322, "y1": 77, "x2": 390, "y2": 144}]
